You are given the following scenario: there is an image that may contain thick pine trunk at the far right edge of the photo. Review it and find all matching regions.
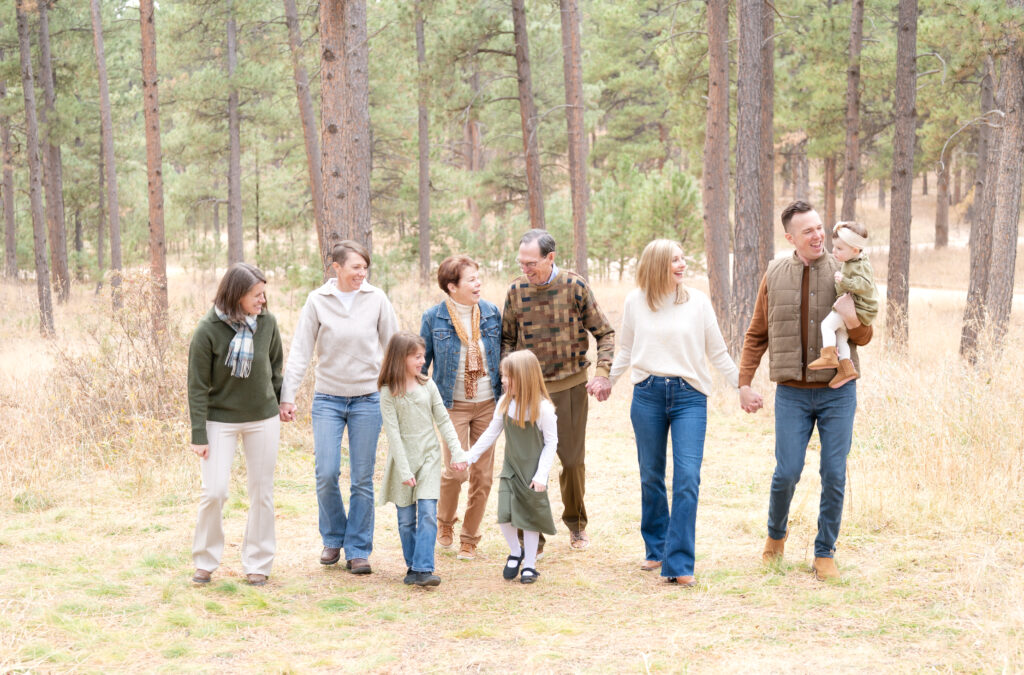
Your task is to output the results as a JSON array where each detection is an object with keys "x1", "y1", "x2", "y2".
[{"x1": 985, "y1": 35, "x2": 1024, "y2": 345}]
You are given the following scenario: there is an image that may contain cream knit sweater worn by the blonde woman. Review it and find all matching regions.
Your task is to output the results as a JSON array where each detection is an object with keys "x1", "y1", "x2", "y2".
[{"x1": 609, "y1": 288, "x2": 739, "y2": 395}]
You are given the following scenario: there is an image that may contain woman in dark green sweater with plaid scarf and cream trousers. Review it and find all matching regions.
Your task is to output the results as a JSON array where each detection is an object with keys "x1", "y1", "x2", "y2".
[{"x1": 188, "y1": 262, "x2": 284, "y2": 586}]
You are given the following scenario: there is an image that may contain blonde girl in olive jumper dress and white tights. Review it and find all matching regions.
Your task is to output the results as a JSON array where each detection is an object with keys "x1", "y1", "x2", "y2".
[{"x1": 469, "y1": 349, "x2": 558, "y2": 584}]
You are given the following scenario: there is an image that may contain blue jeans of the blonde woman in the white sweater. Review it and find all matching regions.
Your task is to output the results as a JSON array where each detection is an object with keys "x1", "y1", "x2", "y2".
[{"x1": 630, "y1": 375, "x2": 708, "y2": 577}]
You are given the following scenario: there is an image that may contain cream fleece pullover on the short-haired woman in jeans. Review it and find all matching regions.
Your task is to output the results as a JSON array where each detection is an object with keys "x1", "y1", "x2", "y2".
[{"x1": 281, "y1": 279, "x2": 398, "y2": 404}]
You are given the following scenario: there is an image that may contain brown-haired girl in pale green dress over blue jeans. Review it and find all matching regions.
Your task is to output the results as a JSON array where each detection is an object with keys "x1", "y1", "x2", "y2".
[{"x1": 377, "y1": 331, "x2": 466, "y2": 586}]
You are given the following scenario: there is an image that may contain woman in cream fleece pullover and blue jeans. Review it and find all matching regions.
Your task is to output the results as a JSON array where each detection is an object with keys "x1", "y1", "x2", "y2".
[{"x1": 281, "y1": 240, "x2": 398, "y2": 575}]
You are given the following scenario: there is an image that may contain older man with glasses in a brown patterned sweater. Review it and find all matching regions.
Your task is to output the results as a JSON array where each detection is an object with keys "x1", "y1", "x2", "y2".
[{"x1": 502, "y1": 229, "x2": 615, "y2": 550}]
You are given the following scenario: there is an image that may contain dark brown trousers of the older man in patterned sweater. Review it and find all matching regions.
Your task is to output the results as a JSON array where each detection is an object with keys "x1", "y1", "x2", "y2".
[{"x1": 551, "y1": 382, "x2": 589, "y2": 530}]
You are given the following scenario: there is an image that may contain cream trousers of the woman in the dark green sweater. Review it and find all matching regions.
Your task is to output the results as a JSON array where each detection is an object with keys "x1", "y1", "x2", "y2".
[{"x1": 193, "y1": 415, "x2": 281, "y2": 577}]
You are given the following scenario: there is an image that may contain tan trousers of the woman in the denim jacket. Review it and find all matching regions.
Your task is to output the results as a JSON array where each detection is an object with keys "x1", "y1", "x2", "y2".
[{"x1": 437, "y1": 399, "x2": 495, "y2": 546}]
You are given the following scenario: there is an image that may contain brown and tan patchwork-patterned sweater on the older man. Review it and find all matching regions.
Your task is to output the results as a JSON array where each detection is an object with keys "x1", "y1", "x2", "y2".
[{"x1": 502, "y1": 269, "x2": 615, "y2": 391}]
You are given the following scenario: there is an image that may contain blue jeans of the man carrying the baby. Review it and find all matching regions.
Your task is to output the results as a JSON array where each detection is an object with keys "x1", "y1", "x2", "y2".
[{"x1": 768, "y1": 382, "x2": 857, "y2": 558}]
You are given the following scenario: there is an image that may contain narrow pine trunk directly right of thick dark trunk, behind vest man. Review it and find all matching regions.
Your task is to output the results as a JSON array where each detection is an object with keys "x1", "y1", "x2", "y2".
[{"x1": 758, "y1": 0, "x2": 775, "y2": 282}]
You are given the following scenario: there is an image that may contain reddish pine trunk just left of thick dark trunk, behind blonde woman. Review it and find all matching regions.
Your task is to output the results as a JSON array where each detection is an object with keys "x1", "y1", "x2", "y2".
[{"x1": 700, "y1": 0, "x2": 735, "y2": 335}]
